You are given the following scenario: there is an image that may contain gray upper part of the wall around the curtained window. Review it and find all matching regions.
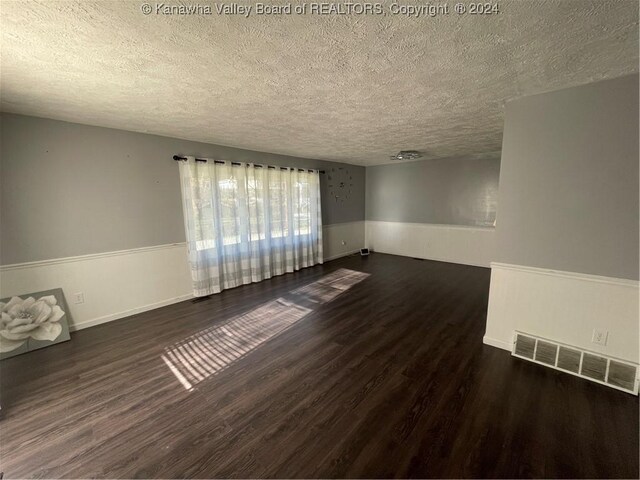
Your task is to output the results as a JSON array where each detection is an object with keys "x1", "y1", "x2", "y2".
[{"x1": 0, "y1": 113, "x2": 365, "y2": 265}]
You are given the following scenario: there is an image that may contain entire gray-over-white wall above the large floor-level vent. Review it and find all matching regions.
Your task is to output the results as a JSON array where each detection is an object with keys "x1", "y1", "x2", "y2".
[{"x1": 484, "y1": 75, "x2": 640, "y2": 362}]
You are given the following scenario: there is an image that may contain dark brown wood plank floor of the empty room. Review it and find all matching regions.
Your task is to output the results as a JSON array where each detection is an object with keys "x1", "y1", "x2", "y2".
[{"x1": 0, "y1": 254, "x2": 639, "y2": 478}]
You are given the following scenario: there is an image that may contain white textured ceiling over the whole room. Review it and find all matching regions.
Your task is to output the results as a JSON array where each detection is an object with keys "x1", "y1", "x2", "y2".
[{"x1": 0, "y1": 0, "x2": 638, "y2": 165}]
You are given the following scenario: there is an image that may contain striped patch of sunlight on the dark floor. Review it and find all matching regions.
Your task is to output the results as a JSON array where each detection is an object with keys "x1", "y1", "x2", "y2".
[{"x1": 162, "y1": 268, "x2": 369, "y2": 390}]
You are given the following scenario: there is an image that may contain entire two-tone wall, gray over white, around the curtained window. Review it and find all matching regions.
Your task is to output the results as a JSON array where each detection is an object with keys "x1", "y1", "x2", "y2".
[{"x1": 0, "y1": 113, "x2": 365, "y2": 329}]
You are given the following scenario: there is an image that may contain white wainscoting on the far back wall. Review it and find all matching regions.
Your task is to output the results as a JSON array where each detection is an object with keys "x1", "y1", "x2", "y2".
[{"x1": 366, "y1": 220, "x2": 495, "y2": 267}]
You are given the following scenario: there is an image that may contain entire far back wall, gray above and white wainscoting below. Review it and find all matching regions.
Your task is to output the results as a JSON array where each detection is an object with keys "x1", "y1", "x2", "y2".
[{"x1": 366, "y1": 153, "x2": 500, "y2": 267}]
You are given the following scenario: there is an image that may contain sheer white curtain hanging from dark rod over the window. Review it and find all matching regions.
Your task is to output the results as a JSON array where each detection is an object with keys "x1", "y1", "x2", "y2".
[{"x1": 179, "y1": 157, "x2": 322, "y2": 296}]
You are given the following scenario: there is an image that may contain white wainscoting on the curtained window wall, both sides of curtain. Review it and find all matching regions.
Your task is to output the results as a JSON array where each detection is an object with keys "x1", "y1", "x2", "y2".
[{"x1": 0, "y1": 222, "x2": 364, "y2": 330}]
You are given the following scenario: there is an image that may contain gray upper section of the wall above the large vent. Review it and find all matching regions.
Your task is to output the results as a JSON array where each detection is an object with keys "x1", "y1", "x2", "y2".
[{"x1": 496, "y1": 75, "x2": 640, "y2": 279}]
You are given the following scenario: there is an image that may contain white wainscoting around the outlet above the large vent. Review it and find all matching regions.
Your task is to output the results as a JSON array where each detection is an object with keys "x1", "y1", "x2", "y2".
[{"x1": 484, "y1": 263, "x2": 640, "y2": 363}]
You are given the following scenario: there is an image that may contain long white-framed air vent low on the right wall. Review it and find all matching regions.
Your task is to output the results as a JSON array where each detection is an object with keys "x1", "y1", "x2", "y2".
[{"x1": 512, "y1": 332, "x2": 638, "y2": 395}]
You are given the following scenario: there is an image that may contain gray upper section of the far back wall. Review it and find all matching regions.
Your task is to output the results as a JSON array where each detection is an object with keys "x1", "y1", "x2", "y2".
[{"x1": 366, "y1": 154, "x2": 500, "y2": 226}]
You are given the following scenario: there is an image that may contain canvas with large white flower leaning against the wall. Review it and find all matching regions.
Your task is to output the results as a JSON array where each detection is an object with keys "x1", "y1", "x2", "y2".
[{"x1": 0, "y1": 288, "x2": 71, "y2": 359}]
